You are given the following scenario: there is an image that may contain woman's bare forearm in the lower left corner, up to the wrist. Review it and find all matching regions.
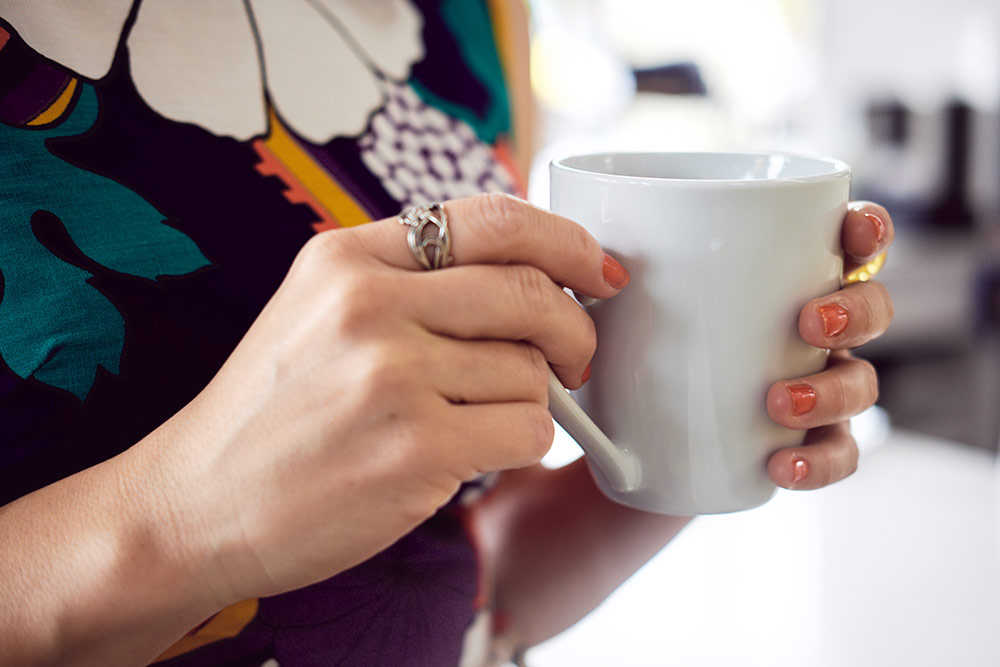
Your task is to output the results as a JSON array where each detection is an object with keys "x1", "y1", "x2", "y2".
[{"x1": 0, "y1": 430, "x2": 223, "y2": 665}]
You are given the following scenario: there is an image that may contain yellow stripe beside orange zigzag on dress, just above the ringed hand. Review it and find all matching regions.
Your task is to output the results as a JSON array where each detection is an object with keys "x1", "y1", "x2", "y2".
[{"x1": 264, "y1": 110, "x2": 372, "y2": 227}]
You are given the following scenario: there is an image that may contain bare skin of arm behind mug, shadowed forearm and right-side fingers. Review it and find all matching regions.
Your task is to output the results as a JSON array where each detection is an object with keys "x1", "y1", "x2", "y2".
[{"x1": 477, "y1": 202, "x2": 893, "y2": 647}]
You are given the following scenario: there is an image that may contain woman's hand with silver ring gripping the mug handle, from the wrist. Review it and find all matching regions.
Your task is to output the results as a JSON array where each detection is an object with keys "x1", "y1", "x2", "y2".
[{"x1": 134, "y1": 194, "x2": 628, "y2": 605}]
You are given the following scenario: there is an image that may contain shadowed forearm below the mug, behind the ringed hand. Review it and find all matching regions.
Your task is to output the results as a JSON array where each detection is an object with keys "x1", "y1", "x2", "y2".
[{"x1": 477, "y1": 459, "x2": 690, "y2": 646}]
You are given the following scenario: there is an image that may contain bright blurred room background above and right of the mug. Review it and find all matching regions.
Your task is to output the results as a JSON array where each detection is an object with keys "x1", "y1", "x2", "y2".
[{"x1": 530, "y1": 0, "x2": 1000, "y2": 450}]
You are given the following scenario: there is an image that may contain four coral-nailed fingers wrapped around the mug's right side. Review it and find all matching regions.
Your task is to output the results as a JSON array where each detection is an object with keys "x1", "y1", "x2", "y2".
[{"x1": 767, "y1": 202, "x2": 894, "y2": 489}]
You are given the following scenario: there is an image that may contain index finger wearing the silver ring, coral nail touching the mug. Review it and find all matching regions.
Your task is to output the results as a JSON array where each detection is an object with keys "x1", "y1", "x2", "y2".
[{"x1": 348, "y1": 193, "x2": 628, "y2": 299}]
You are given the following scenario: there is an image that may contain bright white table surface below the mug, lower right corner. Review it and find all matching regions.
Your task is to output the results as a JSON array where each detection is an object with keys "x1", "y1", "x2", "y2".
[{"x1": 527, "y1": 431, "x2": 1000, "y2": 667}]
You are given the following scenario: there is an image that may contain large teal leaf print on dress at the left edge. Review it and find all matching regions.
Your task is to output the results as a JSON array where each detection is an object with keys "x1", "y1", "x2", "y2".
[{"x1": 0, "y1": 85, "x2": 209, "y2": 400}]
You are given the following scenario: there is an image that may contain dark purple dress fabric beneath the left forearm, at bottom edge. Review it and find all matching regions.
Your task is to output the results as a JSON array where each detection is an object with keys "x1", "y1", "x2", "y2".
[{"x1": 159, "y1": 512, "x2": 478, "y2": 667}]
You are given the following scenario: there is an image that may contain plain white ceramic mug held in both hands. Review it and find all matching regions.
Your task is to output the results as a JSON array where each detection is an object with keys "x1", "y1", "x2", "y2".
[{"x1": 549, "y1": 153, "x2": 850, "y2": 514}]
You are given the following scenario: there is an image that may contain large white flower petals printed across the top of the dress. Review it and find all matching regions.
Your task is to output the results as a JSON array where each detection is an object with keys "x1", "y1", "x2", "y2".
[{"x1": 0, "y1": 0, "x2": 424, "y2": 144}]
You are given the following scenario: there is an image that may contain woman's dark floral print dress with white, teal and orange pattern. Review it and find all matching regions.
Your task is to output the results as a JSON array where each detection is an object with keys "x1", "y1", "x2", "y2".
[{"x1": 0, "y1": 0, "x2": 519, "y2": 667}]
